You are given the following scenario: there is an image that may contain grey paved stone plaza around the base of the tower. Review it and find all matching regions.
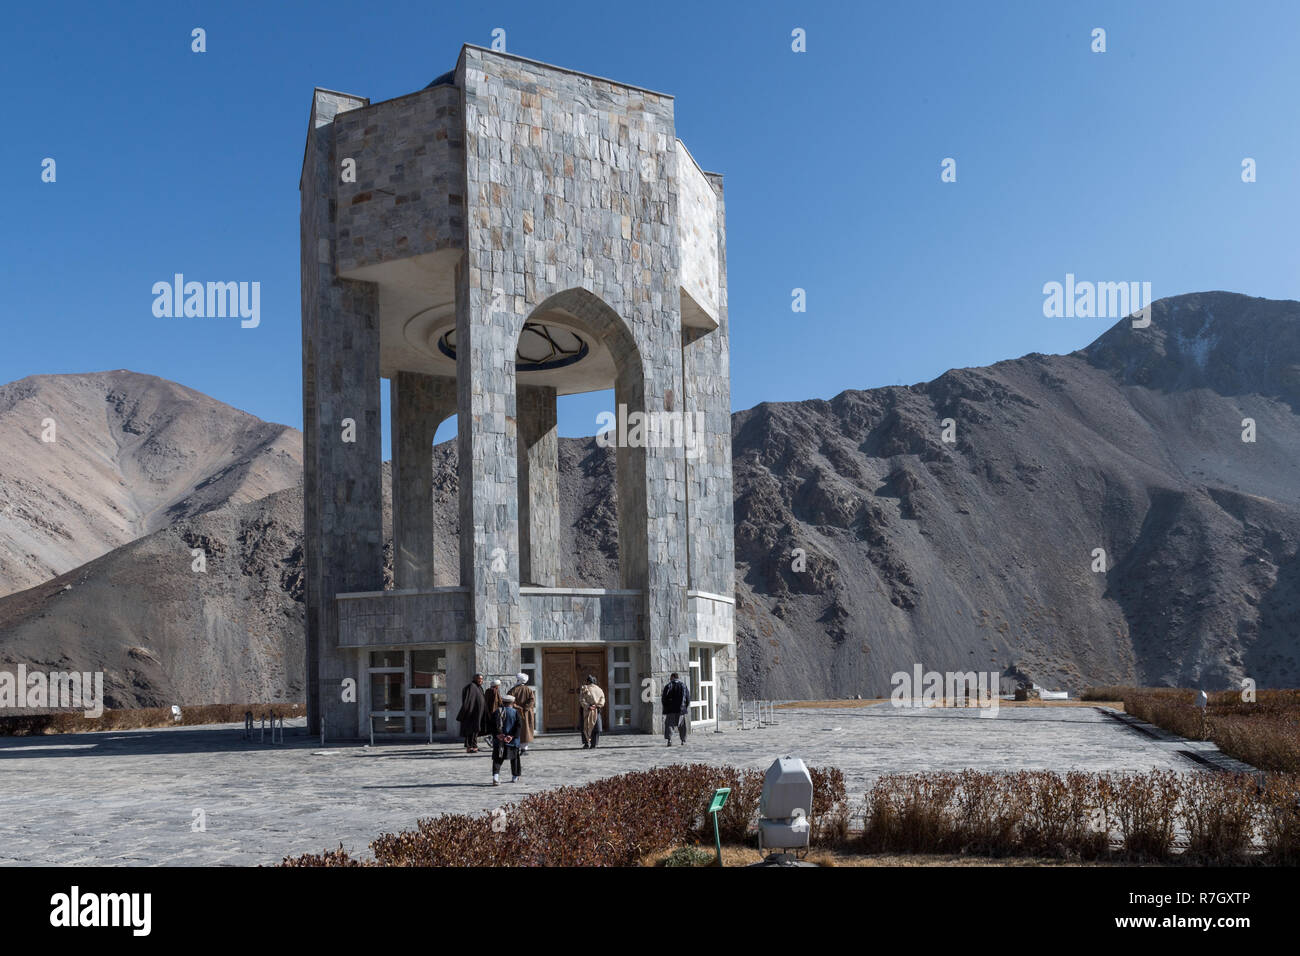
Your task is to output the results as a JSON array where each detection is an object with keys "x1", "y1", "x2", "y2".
[{"x1": 0, "y1": 704, "x2": 1217, "y2": 865}]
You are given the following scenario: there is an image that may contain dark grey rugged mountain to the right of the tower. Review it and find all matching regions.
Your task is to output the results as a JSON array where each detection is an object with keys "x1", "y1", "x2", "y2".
[{"x1": 732, "y1": 293, "x2": 1300, "y2": 697}]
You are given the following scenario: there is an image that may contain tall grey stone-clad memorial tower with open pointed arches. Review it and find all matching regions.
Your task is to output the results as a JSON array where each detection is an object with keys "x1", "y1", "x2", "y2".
[{"x1": 300, "y1": 46, "x2": 738, "y2": 737}]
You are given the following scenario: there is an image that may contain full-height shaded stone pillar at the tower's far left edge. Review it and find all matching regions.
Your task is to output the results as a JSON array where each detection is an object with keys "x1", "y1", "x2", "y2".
[{"x1": 300, "y1": 91, "x2": 384, "y2": 737}]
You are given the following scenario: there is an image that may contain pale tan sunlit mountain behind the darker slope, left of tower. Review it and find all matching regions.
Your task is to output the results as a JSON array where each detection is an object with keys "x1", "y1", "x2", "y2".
[{"x1": 0, "y1": 369, "x2": 303, "y2": 596}]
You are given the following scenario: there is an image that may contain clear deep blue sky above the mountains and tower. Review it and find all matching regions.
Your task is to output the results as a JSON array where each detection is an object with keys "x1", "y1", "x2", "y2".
[{"x1": 0, "y1": 0, "x2": 1300, "y2": 454}]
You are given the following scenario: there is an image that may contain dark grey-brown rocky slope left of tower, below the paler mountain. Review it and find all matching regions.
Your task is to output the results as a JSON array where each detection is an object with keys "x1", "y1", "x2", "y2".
[{"x1": 0, "y1": 485, "x2": 306, "y2": 708}]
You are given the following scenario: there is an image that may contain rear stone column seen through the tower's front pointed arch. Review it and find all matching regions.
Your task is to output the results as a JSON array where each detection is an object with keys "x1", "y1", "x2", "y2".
[{"x1": 515, "y1": 385, "x2": 560, "y2": 588}]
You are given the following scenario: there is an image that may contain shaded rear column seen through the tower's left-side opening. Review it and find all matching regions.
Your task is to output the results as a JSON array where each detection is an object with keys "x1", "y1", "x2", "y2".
[{"x1": 389, "y1": 372, "x2": 456, "y2": 588}]
